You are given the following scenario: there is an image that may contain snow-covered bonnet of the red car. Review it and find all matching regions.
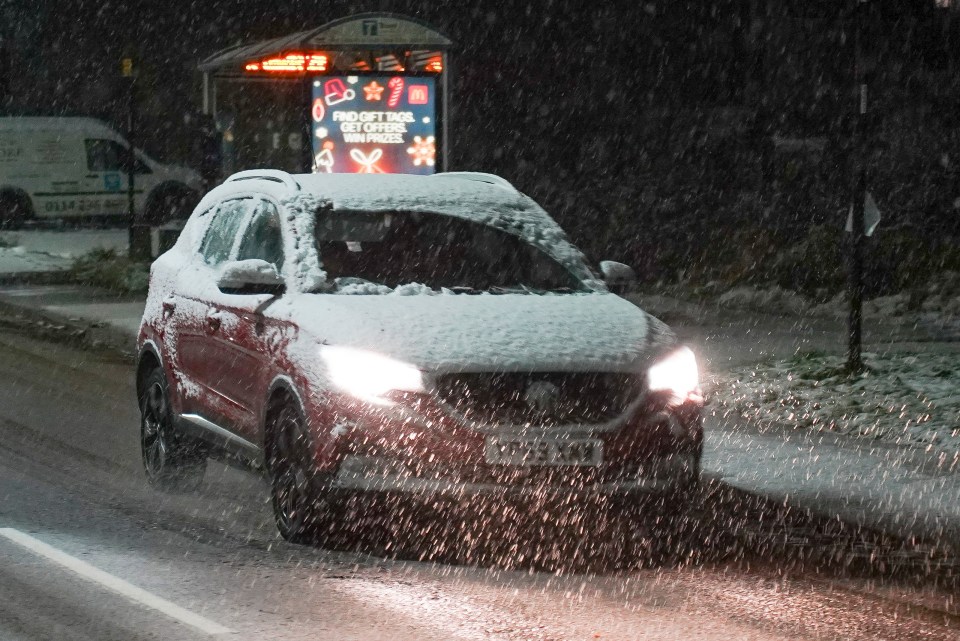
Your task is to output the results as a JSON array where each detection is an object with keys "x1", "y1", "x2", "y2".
[{"x1": 278, "y1": 293, "x2": 676, "y2": 373}]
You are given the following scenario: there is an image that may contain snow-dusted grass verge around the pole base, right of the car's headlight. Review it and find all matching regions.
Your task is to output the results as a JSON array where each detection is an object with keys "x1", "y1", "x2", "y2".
[{"x1": 708, "y1": 353, "x2": 960, "y2": 456}]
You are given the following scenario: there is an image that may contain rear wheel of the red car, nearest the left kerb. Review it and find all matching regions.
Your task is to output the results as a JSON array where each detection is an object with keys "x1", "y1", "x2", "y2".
[{"x1": 140, "y1": 368, "x2": 207, "y2": 492}]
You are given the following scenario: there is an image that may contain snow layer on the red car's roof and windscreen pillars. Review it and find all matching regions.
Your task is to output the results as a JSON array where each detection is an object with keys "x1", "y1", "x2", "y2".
[{"x1": 283, "y1": 174, "x2": 604, "y2": 291}]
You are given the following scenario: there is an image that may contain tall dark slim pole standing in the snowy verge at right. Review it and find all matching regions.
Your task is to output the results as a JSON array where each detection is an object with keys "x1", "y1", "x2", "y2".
[{"x1": 847, "y1": 0, "x2": 868, "y2": 373}]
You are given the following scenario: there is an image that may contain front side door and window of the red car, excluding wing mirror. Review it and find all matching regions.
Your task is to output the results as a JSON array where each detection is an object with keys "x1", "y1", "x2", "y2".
[{"x1": 201, "y1": 200, "x2": 284, "y2": 441}]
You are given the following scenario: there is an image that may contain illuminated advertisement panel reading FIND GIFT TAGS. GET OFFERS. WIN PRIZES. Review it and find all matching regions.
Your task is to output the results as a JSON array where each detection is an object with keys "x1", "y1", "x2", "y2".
[{"x1": 310, "y1": 76, "x2": 437, "y2": 174}]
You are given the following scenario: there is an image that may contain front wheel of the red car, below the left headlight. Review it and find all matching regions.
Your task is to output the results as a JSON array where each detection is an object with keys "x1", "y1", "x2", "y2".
[{"x1": 268, "y1": 401, "x2": 339, "y2": 543}]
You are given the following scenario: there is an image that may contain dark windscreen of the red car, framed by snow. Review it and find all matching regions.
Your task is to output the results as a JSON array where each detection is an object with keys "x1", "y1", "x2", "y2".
[{"x1": 316, "y1": 211, "x2": 587, "y2": 294}]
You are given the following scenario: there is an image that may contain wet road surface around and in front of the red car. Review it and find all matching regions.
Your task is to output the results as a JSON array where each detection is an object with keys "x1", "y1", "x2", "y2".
[{"x1": 0, "y1": 328, "x2": 960, "y2": 641}]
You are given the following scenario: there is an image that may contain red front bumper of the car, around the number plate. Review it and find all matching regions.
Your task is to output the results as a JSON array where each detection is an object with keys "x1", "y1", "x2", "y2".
[{"x1": 311, "y1": 390, "x2": 703, "y2": 498}]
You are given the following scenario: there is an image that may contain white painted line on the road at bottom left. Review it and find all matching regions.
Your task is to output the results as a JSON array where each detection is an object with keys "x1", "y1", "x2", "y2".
[{"x1": 0, "y1": 528, "x2": 232, "y2": 634}]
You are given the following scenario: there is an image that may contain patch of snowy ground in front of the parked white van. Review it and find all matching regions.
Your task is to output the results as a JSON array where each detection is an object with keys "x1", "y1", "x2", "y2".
[{"x1": 0, "y1": 229, "x2": 128, "y2": 274}]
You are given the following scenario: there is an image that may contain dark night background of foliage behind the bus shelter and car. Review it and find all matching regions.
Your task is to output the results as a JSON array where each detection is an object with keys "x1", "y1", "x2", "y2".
[{"x1": 0, "y1": 0, "x2": 960, "y2": 291}]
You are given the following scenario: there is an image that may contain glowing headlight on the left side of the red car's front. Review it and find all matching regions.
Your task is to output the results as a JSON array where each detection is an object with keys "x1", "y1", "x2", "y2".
[{"x1": 320, "y1": 345, "x2": 424, "y2": 405}]
